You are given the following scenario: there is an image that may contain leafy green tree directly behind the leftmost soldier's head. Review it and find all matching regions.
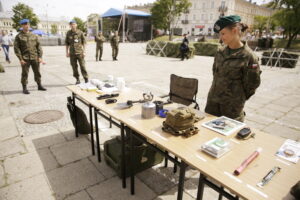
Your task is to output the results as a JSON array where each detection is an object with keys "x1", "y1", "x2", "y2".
[{"x1": 11, "y1": 3, "x2": 40, "y2": 31}]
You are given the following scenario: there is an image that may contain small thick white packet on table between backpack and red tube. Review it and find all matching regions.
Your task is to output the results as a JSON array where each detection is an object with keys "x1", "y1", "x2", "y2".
[{"x1": 201, "y1": 137, "x2": 232, "y2": 158}]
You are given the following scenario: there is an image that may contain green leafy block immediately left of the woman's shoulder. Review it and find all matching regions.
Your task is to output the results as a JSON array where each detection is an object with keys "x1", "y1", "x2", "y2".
[{"x1": 194, "y1": 42, "x2": 221, "y2": 56}]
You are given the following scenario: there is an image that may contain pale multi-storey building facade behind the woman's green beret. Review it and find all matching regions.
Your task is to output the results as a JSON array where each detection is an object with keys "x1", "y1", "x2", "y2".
[{"x1": 173, "y1": 0, "x2": 273, "y2": 35}]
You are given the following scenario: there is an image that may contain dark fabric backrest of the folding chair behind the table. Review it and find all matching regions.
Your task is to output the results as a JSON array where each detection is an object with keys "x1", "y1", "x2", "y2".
[{"x1": 169, "y1": 74, "x2": 199, "y2": 109}]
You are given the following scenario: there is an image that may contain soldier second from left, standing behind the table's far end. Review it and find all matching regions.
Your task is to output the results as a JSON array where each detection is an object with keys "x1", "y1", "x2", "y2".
[{"x1": 66, "y1": 20, "x2": 88, "y2": 84}]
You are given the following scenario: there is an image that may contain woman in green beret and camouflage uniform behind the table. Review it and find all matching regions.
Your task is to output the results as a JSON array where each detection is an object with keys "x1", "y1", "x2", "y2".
[{"x1": 205, "y1": 15, "x2": 261, "y2": 121}]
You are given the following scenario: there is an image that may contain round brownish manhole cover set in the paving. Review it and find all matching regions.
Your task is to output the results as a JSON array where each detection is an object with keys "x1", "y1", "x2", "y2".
[{"x1": 24, "y1": 110, "x2": 64, "y2": 124}]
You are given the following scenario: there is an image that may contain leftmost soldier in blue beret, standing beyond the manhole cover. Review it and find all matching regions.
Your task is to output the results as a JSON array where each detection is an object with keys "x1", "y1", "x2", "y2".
[{"x1": 14, "y1": 19, "x2": 46, "y2": 94}]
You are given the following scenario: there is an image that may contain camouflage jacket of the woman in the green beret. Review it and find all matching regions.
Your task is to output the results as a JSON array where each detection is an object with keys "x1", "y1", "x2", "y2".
[{"x1": 208, "y1": 44, "x2": 261, "y2": 104}]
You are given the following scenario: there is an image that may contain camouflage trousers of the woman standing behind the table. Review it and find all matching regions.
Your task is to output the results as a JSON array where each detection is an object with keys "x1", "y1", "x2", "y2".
[{"x1": 205, "y1": 99, "x2": 245, "y2": 122}]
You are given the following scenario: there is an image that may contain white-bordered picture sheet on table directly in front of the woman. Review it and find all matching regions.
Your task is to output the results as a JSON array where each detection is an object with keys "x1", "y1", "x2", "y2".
[{"x1": 202, "y1": 116, "x2": 246, "y2": 136}]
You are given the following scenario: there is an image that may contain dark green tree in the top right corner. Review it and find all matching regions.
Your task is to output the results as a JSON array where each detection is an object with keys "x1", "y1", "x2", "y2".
[{"x1": 270, "y1": 0, "x2": 300, "y2": 48}]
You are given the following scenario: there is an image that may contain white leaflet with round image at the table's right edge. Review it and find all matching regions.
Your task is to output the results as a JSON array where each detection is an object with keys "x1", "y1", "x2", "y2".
[{"x1": 276, "y1": 139, "x2": 300, "y2": 163}]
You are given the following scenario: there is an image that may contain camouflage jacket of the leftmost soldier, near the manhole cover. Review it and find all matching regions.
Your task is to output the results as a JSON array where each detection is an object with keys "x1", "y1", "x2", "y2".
[{"x1": 14, "y1": 31, "x2": 43, "y2": 60}]
